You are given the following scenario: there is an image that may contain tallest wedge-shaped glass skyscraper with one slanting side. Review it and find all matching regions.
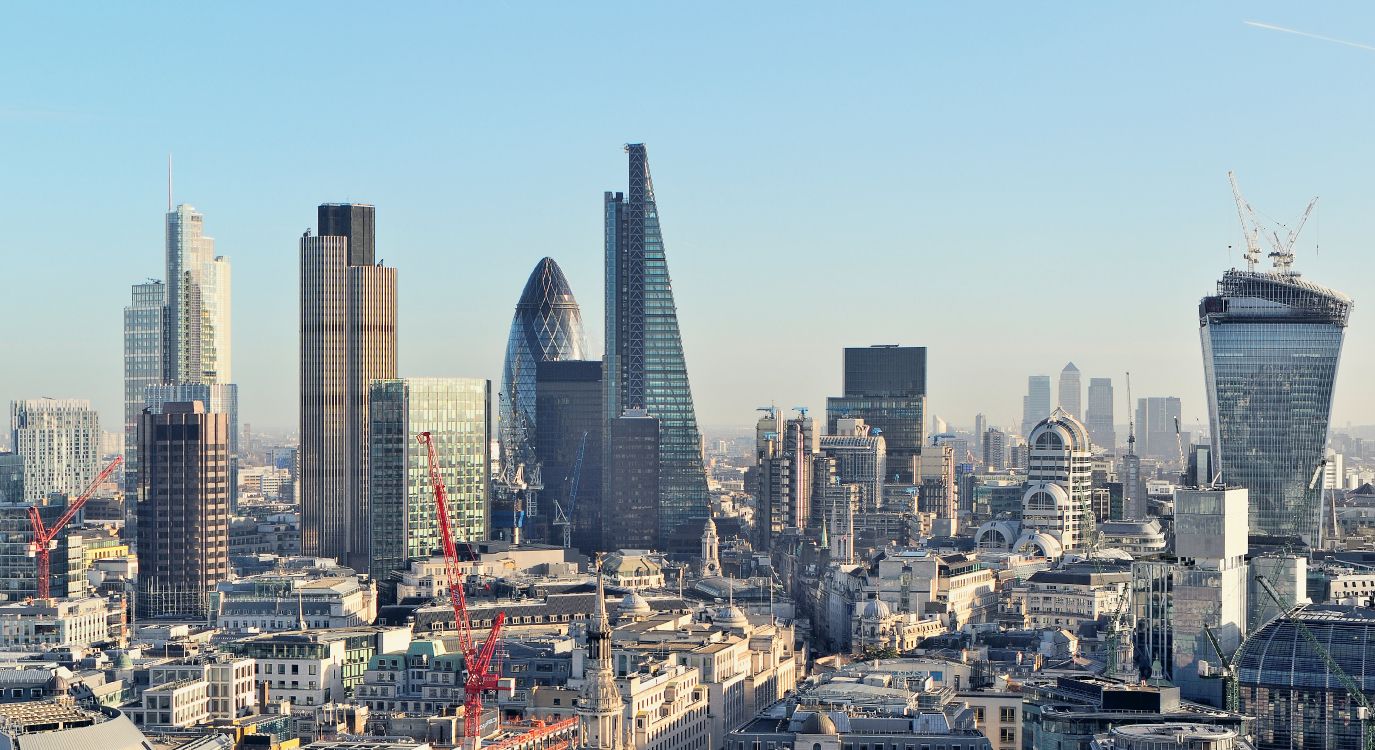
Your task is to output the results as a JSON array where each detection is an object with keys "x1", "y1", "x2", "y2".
[{"x1": 604, "y1": 143, "x2": 708, "y2": 550}]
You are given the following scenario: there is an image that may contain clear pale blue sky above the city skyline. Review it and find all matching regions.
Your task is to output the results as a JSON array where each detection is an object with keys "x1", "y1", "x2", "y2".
[{"x1": 0, "y1": 1, "x2": 1375, "y2": 429}]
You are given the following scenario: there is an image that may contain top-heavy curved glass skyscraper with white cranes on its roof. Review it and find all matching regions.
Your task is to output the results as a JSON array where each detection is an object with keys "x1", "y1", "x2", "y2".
[{"x1": 1199, "y1": 270, "x2": 1352, "y2": 544}]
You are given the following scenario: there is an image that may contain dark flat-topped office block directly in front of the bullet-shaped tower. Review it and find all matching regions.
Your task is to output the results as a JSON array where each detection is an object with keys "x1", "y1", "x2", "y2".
[{"x1": 535, "y1": 359, "x2": 602, "y2": 555}]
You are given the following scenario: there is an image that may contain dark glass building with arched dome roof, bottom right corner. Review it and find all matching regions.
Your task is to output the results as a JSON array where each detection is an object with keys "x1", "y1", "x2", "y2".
[{"x1": 1233, "y1": 604, "x2": 1375, "y2": 750}]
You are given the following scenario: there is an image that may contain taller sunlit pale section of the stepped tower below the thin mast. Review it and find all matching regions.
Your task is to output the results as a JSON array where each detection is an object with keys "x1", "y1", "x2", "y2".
[{"x1": 165, "y1": 204, "x2": 232, "y2": 383}]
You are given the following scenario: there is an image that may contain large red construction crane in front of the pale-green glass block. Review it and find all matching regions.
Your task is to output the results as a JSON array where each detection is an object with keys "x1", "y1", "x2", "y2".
[{"x1": 415, "y1": 432, "x2": 506, "y2": 750}]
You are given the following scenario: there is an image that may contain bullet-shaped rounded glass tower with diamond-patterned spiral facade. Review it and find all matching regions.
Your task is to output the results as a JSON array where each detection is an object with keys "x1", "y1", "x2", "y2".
[{"x1": 499, "y1": 257, "x2": 586, "y2": 465}]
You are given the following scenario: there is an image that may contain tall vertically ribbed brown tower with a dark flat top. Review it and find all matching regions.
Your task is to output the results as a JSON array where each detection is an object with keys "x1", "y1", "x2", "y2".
[{"x1": 298, "y1": 204, "x2": 396, "y2": 572}]
